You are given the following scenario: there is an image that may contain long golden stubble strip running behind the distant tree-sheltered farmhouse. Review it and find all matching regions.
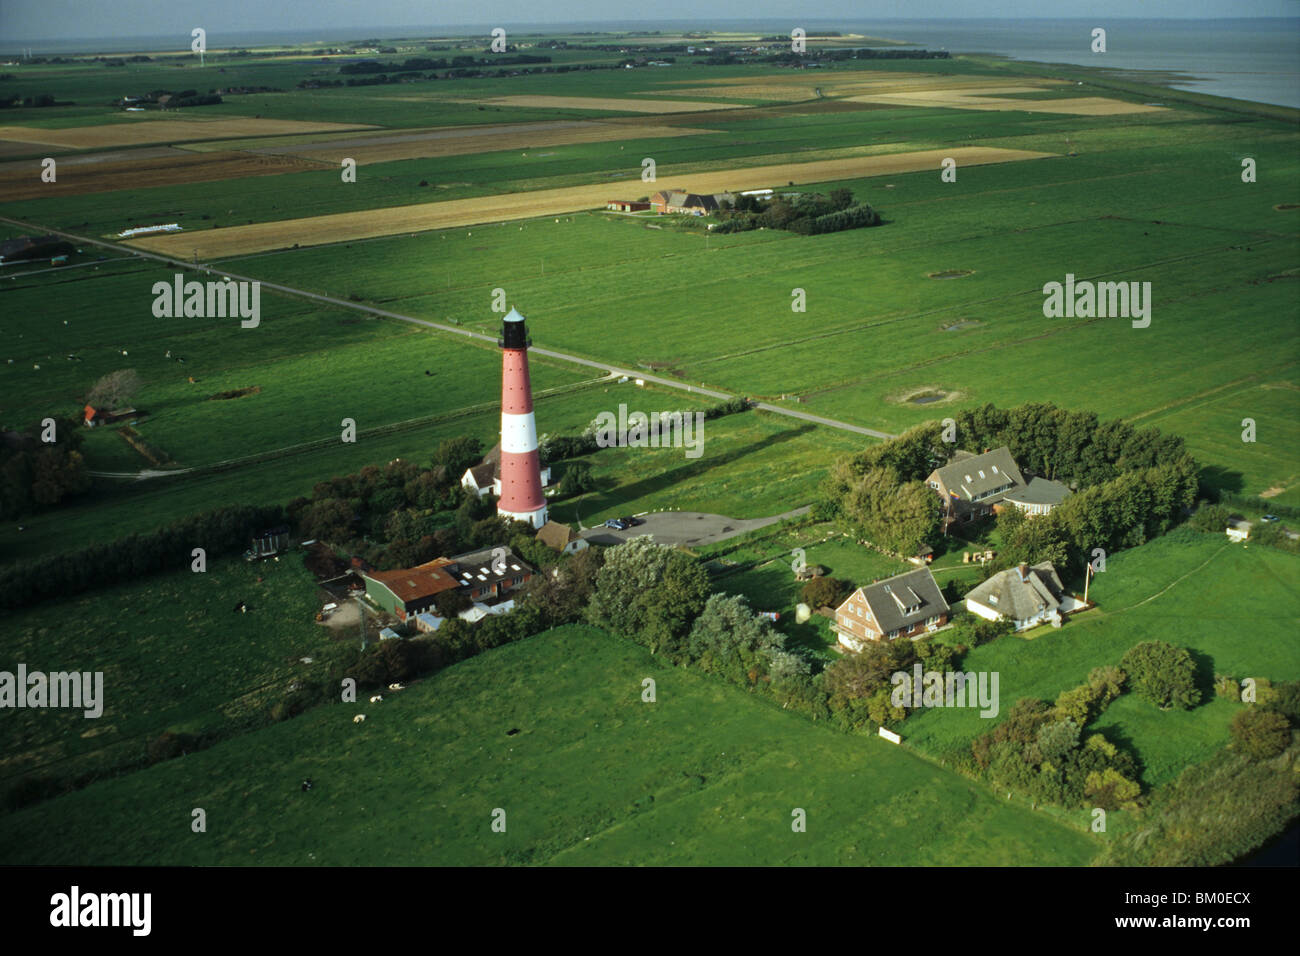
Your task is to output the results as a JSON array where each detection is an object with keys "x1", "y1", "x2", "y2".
[{"x1": 129, "y1": 146, "x2": 1054, "y2": 259}]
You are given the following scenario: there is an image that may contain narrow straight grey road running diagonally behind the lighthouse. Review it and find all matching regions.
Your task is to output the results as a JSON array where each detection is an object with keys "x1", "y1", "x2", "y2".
[{"x1": 0, "y1": 216, "x2": 894, "y2": 440}]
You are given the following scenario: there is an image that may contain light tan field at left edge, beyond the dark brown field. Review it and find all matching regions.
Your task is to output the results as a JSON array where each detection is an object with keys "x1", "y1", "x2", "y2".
[{"x1": 0, "y1": 113, "x2": 376, "y2": 150}]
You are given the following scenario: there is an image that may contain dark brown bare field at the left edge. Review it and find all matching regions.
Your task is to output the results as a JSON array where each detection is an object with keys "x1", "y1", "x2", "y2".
[{"x1": 0, "y1": 150, "x2": 320, "y2": 200}]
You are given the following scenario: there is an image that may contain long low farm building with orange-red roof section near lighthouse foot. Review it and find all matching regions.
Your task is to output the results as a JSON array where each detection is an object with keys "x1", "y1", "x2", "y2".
[{"x1": 361, "y1": 548, "x2": 534, "y2": 622}]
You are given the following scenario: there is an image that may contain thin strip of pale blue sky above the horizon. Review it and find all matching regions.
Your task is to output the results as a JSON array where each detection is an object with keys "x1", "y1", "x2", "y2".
[{"x1": 0, "y1": 0, "x2": 1300, "y2": 42}]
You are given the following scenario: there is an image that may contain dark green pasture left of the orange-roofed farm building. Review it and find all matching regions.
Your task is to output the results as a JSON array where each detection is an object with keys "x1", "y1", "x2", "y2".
[{"x1": 0, "y1": 554, "x2": 358, "y2": 786}]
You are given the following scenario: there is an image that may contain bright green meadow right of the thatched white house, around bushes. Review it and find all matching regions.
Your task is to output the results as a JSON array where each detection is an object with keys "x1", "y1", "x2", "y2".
[{"x1": 901, "y1": 531, "x2": 1300, "y2": 787}]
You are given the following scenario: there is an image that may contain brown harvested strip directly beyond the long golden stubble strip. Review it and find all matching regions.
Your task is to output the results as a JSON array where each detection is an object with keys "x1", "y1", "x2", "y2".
[{"x1": 250, "y1": 120, "x2": 714, "y2": 165}]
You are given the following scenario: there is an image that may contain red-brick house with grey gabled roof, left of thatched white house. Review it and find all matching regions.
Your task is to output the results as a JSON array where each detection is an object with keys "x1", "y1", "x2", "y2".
[{"x1": 831, "y1": 567, "x2": 950, "y2": 650}]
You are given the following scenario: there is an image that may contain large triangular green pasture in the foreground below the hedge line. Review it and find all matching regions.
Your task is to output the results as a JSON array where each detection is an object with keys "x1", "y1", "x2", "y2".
[{"x1": 0, "y1": 627, "x2": 1099, "y2": 866}]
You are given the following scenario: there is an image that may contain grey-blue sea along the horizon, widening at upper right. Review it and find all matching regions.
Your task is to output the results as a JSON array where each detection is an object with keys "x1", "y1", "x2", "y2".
[{"x1": 0, "y1": 17, "x2": 1300, "y2": 108}]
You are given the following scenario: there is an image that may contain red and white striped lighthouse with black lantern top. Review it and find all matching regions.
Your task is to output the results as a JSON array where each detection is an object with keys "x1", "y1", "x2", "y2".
[{"x1": 497, "y1": 308, "x2": 546, "y2": 528}]
